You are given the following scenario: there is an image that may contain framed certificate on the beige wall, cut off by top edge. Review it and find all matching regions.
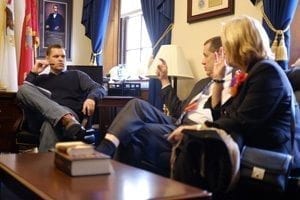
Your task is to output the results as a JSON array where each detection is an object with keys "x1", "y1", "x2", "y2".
[{"x1": 187, "y1": 0, "x2": 234, "y2": 23}]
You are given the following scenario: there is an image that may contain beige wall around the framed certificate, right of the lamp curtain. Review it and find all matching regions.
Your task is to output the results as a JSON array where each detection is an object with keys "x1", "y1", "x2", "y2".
[{"x1": 172, "y1": 0, "x2": 261, "y2": 97}]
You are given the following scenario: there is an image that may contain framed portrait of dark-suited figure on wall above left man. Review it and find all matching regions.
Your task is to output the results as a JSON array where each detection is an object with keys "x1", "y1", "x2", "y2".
[{"x1": 37, "y1": 0, "x2": 73, "y2": 60}]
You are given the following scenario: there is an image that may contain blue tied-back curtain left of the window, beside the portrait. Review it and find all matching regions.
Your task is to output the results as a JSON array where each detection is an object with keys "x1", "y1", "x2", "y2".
[{"x1": 81, "y1": 0, "x2": 111, "y2": 65}]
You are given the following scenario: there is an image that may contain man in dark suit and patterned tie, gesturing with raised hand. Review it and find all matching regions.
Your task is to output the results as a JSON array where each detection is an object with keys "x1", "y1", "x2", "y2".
[{"x1": 96, "y1": 37, "x2": 232, "y2": 173}]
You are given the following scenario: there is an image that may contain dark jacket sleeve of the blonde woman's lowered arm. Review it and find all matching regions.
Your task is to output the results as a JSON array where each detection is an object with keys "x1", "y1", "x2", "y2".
[{"x1": 214, "y1": 64, "x2": 289, "y2": 132}]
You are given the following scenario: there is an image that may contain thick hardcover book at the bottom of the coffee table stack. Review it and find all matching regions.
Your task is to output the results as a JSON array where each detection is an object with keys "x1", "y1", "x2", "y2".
[{"x1": 54, "y1": 150, "x2": 112, "y2": 176}]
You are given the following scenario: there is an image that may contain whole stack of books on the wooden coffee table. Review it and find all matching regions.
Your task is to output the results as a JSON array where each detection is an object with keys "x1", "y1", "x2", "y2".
[{"x1": 54, "y1": 142, "x2": 112, "y2": 176}]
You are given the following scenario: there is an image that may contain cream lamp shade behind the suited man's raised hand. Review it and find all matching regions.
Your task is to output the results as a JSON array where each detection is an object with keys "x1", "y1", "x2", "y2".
[{"x1": 147, "y1": 44, "x2": 194, "y2": 78}]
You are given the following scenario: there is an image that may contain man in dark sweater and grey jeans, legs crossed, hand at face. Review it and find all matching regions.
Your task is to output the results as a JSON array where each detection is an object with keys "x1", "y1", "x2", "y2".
[{"x1": 17, "y1": 45, "x2": 106, "y2": 152}]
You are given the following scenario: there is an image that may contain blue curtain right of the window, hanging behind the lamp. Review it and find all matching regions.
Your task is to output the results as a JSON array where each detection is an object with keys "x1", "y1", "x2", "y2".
[{"x1": 141, "y1": 0, "x2": 174, "y2": 109}]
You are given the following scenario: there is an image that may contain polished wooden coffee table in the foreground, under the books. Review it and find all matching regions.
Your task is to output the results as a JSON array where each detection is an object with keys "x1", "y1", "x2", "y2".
[{"x1": 0, "y1": 153, "x2": 210, "y2": 200}]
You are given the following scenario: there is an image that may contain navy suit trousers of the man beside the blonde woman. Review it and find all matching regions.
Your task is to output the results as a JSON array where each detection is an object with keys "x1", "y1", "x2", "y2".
[{"x1": 108, "y1": 99, "x2": 176, "y2": 174}]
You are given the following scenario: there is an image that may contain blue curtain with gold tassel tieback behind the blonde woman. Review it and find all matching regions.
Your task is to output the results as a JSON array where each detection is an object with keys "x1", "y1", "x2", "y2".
[{"x1": 263, "y1": 0, "x2": 298, "y2": 69}]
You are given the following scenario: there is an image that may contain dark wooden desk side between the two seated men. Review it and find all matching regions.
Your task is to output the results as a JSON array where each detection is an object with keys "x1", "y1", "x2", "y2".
[{"x1": 97, "y1": 96, "x2": 134, "y2": 134}]
